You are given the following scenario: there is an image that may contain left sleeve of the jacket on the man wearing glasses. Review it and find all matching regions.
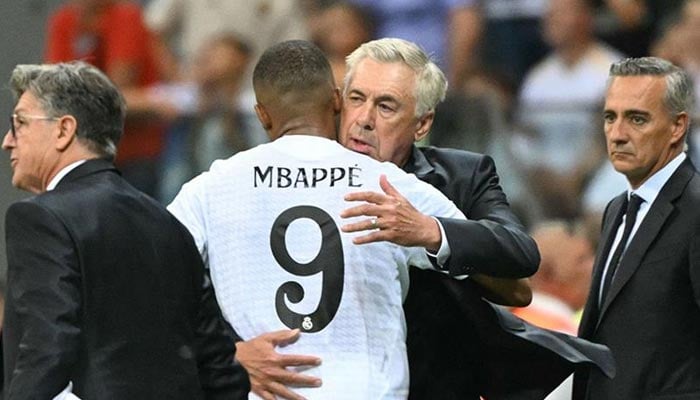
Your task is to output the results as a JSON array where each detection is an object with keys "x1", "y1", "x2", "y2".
[{"x1": 3, "y1": 202, "x2": 81, "y2": 400}]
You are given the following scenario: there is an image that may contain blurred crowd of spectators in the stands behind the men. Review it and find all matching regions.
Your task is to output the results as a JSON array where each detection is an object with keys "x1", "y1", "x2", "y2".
[{"x1": 45, "y1": 0, "x2": 700, "y2": 322}]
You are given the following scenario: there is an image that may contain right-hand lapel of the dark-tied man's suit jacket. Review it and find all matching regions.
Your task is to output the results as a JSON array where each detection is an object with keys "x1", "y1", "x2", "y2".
[{"x1": 598, "y1": 159, "x2": 694, "y2": 323}]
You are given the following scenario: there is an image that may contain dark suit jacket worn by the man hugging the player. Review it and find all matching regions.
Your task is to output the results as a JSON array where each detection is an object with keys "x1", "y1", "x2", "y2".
[{"x1": 404, "y1": 147, "x2": 613, "y2": 400}]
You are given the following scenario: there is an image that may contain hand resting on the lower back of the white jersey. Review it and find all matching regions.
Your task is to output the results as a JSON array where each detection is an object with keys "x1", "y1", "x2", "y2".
[{"x1": 236, "y1": 329, "x2": 321, "y2": 400}]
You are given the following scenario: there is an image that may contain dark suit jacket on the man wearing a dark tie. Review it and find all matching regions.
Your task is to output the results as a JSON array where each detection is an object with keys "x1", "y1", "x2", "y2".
[{"x1": 574, "y1": 159, "x2": 700, "y2": 400}]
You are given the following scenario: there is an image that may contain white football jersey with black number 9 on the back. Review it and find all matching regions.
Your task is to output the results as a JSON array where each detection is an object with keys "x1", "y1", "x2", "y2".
[{"x1": 168, "y1": 135, "x2": 464, "y2": 400}]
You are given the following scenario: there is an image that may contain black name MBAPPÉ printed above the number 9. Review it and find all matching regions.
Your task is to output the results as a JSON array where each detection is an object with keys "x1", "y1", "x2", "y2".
[{"x1": 253, "y1": 165, "x2": 362, "y2": 189}]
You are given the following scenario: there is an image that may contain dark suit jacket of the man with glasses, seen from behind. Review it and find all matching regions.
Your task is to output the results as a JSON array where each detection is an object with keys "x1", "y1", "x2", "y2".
[{"x1": 3, "y1": 160, "x2": 248, "y2": 400}]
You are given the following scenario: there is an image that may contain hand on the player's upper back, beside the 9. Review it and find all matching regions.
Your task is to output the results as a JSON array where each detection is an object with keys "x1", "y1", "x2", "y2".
[{"x1": 340, "y1": 175, "x2": 442, "y2": 252}]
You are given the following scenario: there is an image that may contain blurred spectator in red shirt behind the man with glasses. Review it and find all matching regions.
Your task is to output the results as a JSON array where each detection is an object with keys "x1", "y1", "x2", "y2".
[{"x1": 44, "y1": 0, "x2": 165, "y2": 196}]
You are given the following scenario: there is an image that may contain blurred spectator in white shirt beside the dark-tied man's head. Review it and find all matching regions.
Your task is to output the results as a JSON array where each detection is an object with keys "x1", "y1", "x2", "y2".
[{"x1": 513, "y1": 0, "x2": 622, "y2": 218}]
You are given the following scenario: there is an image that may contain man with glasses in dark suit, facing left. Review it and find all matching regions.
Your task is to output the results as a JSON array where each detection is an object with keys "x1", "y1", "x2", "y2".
[{"x1": 2, "y1": 62, "x2": 248, "y2": 400}]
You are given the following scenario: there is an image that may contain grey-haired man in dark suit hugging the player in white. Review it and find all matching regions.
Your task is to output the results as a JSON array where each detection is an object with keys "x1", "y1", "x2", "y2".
[{"x1": 237, "y1": 39, "x2": 612, "y2": 399}]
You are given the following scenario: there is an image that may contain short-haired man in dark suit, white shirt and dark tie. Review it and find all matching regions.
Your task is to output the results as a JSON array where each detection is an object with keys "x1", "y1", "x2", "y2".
[{"x1": 574, "y1": 57, "x2": 700, "y2": 400}]
